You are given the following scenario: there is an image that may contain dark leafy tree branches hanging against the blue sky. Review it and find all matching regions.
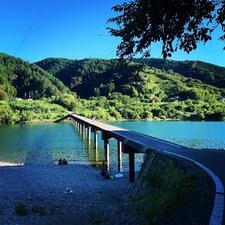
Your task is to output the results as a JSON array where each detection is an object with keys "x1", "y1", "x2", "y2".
[{"x1": 108, "y1": 0, "x2": 225, "y2": 59}]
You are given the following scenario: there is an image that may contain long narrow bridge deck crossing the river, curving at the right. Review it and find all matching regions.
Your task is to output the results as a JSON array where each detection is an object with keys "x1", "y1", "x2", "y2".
[{"x1": 70, "y1": 113, "x2": 225, "y2": 224}]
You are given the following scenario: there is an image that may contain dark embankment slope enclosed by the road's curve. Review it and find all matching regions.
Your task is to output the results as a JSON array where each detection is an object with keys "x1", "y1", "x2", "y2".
[{"x1": 134, "y1": 154, "x2": 215, "y2": 225}]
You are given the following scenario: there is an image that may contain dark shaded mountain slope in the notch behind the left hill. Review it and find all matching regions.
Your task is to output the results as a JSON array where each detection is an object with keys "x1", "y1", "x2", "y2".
[{"x1": 36, "y1": 58, "x2": 118, "y2": 98}]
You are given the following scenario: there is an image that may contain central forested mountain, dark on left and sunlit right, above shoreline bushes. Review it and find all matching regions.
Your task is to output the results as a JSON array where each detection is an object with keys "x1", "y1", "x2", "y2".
[{"x1": 37, "y1": 58, "x2": 225, "y2": 101}]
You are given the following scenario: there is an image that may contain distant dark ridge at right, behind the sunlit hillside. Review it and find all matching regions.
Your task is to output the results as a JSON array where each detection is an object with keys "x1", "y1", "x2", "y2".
[{"x1": 133, "y1": 58, "x2": 225, "y2": 88}]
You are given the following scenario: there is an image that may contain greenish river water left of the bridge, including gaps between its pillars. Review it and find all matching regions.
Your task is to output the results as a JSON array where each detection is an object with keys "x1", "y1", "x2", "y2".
[{"x1": 0, "y1": 123, "x2": 143, "y2": 172}]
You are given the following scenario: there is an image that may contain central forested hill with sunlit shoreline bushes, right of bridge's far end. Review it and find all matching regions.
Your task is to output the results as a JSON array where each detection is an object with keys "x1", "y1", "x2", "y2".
[{"x1": 38, "y1": 59, "x2": 225, "y2": 120}]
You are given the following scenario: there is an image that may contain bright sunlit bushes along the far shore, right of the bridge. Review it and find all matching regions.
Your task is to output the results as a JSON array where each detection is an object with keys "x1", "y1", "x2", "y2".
[{"x1": 73, "y1": 93, "x2": 225, "y2": 120}]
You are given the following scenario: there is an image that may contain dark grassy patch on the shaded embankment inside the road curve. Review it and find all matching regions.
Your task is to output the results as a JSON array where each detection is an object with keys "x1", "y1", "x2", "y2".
[{"x1": 134, "y1": 160, "x2": 194, "y2": 224}]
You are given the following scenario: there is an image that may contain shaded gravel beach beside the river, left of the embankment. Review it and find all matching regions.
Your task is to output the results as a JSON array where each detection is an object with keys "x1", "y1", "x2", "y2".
[{"x1": 0, "y1": 164, "x2": 135, "y2": 225}]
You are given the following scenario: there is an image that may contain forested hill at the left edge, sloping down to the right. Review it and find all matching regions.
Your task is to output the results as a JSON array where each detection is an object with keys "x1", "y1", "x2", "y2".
[{"x1": 0, "y1": 53, "x2": 69, "y2": 100}]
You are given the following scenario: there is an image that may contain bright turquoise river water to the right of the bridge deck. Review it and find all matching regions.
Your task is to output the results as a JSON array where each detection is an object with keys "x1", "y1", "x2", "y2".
[{"x1": 107, "y1": 121, "x2": 225, "y2": 149}]
